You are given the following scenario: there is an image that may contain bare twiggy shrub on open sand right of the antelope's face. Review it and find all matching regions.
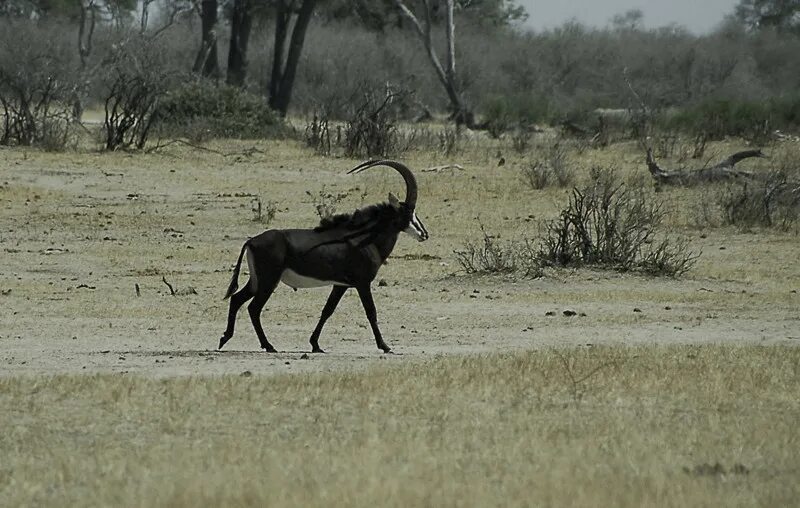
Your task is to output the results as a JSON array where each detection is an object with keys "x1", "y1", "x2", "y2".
[{"x1": 538, "y1": 169, "x2": 696, "y2": 276}]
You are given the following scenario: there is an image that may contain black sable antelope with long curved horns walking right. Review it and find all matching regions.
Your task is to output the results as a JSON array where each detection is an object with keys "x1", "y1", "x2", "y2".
[{"x1": 219, "y1": 160, "x2": 428, "y2": 353}]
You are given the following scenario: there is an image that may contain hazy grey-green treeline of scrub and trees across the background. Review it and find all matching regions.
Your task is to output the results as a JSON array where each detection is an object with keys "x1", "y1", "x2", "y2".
[{"x1": 0, "y1": 0, "x2": 800, "y2": 148}]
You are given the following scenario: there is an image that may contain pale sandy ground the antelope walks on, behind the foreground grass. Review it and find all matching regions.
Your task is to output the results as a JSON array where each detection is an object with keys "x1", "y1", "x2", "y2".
[{"x1": 0, "y1": 143, "x2": 800, "y2": 376}]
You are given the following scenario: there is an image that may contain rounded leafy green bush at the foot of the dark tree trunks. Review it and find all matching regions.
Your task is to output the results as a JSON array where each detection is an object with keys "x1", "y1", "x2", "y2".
[{"x1": 155, "y1": 81, "x2": 286, "y2": 139}]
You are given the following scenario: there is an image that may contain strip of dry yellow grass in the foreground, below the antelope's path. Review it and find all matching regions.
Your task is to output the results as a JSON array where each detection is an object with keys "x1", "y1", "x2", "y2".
[{"x1": 0, "y1": 345, "x2": 800, "y2": 506}]
